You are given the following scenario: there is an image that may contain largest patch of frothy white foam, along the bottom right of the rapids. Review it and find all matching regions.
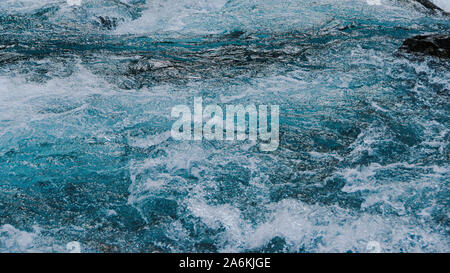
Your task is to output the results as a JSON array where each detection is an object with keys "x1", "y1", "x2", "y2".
[{"x1": 185, "y1": 199, "x2": 447, "y2": 252}]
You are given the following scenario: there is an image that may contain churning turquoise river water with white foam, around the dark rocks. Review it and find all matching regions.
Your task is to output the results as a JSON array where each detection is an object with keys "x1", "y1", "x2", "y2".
[{"x1": 0, "y1": 0, "x2": 450, "y2": 252}]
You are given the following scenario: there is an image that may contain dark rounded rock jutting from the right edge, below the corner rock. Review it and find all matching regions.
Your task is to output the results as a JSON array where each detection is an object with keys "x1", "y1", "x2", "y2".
[{"x1": 400, "y1": 35, "x2": 450, "y2": 58}]
